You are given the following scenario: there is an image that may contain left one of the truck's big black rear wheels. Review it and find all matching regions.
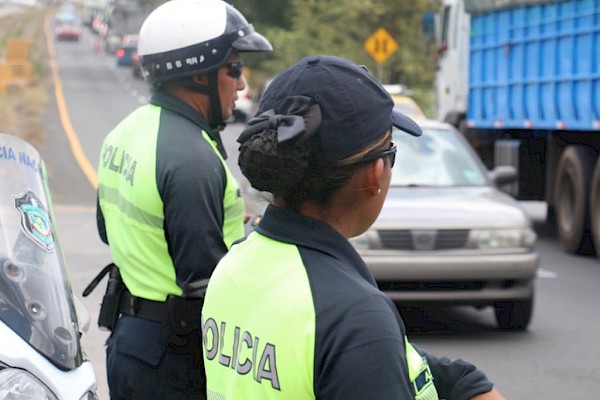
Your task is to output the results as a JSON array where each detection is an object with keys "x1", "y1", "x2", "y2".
[{"x1": 554, "y1": 145, "x2": 596, "y2": 254}]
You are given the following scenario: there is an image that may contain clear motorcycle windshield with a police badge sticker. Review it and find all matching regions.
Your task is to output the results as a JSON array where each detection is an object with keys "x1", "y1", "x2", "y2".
[{"x1": 0, "y1": 134, "x2": 83, "y2": 370}]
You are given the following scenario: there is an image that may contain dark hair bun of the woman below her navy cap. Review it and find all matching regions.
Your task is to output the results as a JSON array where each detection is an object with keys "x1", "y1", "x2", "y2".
[{"x1": 238, "y1": 129, "x2": 310, "y2": 194}]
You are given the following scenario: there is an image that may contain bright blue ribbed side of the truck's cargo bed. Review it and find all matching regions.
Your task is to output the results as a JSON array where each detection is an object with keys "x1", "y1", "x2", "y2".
[{"x1": 467, "y1": 0, "x2": 600, "y2": 131}]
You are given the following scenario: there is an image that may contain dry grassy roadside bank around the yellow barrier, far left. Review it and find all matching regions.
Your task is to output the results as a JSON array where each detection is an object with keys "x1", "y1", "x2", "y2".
[{"x1": 0, "y1": 9, "x2": 55, "y2": 147}]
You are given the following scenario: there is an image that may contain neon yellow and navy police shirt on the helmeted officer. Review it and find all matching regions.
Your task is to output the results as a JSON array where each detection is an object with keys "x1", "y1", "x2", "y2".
[{"x1": 98, "y1": 91, "x2": 244, "y2": 301}]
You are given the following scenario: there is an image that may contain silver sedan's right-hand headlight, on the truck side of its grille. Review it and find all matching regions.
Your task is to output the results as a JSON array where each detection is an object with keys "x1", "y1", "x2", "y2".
[{"x1": 469, "y1": 229, "x2": 537, "y2": 249}]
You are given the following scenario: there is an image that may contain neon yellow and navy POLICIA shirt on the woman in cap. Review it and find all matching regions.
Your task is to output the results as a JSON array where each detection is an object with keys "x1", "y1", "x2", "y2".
[{"x1": 202, "y1": 206, "x2": 438, "y2": 400}]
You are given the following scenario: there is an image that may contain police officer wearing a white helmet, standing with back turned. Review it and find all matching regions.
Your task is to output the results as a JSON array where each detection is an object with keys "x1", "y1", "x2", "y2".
[{"x1": 92, "y1": 0, "x2": 272, "y2": 400}]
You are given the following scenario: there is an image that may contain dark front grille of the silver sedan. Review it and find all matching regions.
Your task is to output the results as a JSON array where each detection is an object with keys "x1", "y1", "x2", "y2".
[{"x1": 378, "y1": 229, "x2": 469, "y2": 251}]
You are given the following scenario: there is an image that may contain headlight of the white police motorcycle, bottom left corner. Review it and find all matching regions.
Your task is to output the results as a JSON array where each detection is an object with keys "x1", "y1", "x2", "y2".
[{"x1": 0, "y1": 368, "x2": 58, "y2": 400}]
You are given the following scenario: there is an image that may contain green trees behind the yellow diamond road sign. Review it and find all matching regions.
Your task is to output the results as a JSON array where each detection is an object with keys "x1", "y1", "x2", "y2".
[{"x1": 235, "y1": 0, "x2": 439, "y2": 114}]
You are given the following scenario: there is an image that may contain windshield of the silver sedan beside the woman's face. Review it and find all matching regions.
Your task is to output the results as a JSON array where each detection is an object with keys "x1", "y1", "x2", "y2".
[{"x1": 391, "y1": 128, "x2": 487, "y2": 186}]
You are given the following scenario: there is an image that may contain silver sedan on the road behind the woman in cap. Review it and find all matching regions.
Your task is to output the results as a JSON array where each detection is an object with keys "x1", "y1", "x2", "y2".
[{"x1": 351, "y1": 120, "x2": 539, "y2": 330}]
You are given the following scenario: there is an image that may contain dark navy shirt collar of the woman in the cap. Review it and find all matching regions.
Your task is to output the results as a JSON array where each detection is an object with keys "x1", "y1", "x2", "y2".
[{"x1": 256, "y1": 204, "x2": 376, "y2": 286}]
